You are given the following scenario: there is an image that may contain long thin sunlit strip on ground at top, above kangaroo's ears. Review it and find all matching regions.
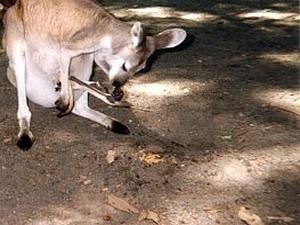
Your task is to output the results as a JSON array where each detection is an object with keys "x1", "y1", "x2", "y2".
[{"x1": 111, "y1": 7, "x2": 218, "y2": 22}]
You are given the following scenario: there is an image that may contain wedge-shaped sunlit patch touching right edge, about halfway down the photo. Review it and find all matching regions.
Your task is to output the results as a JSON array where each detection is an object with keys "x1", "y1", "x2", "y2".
[{"x1": 254, "y1": 90, "x2": 300, "y2": 116}]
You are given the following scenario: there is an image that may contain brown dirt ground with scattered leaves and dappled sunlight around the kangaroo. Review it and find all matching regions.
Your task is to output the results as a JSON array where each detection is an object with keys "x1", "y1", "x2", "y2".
[{"x1": 0, "y1": 0, "x2": 300, "y2": 225}]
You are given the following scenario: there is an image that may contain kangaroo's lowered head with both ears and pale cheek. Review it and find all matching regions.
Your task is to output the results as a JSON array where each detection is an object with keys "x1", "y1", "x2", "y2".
[{"x1": 96, "y1": 22, "x2": 187, "y2": 87}]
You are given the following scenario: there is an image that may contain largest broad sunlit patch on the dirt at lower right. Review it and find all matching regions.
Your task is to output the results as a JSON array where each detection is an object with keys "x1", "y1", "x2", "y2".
[{"x1": 168, "y1": 144, "x2": 300, "y2": 192}]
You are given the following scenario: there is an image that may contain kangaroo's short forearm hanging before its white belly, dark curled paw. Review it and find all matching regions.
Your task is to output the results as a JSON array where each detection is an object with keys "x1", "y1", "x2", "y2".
[{"x1": 55, "y1": 57, "x2": 74, "y2": 117}]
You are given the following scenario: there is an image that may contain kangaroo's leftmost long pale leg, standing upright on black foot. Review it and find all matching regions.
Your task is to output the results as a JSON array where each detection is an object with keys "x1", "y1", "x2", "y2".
[{"x1": 7, "y1": 41, "x2": 34, "y2": 150}]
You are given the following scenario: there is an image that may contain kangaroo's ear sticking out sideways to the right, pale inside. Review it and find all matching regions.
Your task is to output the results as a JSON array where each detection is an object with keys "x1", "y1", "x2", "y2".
[{"x1": 154, "y1": 28, "x2": 187, "y2": 49}]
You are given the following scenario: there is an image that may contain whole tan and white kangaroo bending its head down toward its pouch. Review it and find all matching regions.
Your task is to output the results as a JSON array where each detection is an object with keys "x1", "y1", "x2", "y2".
[{"x1": 2, "y1": 0, "x2": 187, "y2": 150}]
